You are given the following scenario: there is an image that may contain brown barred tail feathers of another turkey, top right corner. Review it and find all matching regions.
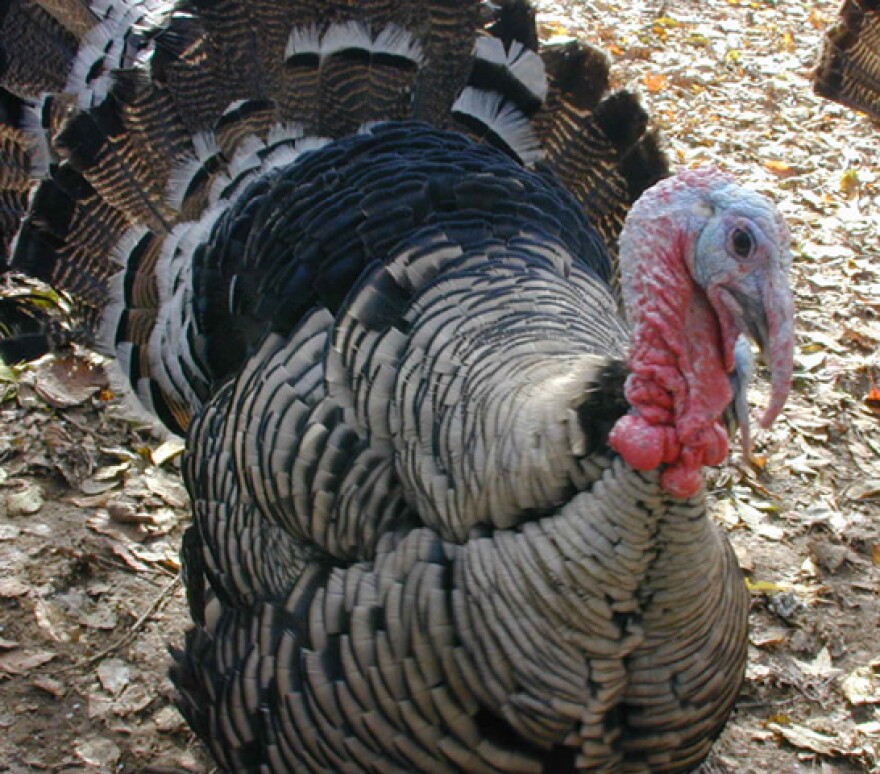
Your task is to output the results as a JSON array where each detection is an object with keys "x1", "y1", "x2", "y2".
[{"x1": 815, "y1": 0, "x2": 880, "y2": 119}]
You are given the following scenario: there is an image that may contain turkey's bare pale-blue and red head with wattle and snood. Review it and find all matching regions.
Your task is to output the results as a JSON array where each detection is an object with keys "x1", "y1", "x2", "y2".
[{"x1": 610, "y1": 168, "x2": 794, "y2": 497}]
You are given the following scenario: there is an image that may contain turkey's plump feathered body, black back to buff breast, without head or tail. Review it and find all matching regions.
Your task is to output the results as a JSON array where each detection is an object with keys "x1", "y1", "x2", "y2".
[{"x1": 175, "y1": 124, "x2": 747, "y2": 771}]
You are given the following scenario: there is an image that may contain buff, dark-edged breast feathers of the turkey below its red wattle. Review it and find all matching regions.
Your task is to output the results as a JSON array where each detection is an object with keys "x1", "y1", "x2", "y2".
[{"x1": 453, "y1": 460, "x2": 747, "y2": 771}]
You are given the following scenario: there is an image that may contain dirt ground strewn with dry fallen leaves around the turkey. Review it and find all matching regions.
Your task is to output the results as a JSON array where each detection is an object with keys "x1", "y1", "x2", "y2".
[{"x1": 0, "y1": 0, "x2": 880, "y2": 774}]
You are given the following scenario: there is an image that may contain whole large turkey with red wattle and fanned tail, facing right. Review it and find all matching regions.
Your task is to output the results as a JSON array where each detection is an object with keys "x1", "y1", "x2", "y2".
[{"x1": 0, "y1": 0, "x2": 793, "y2": 773}]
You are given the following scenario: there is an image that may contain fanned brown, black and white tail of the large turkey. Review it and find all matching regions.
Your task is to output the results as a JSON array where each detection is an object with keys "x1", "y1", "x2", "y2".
[{"x1": 0, "y1": 0, "x2": 666, "y2": 431}]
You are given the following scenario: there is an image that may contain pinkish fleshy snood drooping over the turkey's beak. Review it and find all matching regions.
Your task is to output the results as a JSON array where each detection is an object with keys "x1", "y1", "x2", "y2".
[{"x1": 745, "y1": 268, "x2": 794, "y2": 428}]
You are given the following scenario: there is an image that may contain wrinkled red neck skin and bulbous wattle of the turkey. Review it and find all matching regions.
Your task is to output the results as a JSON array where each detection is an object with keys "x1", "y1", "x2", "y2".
[{"x1": 609, "y1": 234, "x2": 732, "y2": 498}]
